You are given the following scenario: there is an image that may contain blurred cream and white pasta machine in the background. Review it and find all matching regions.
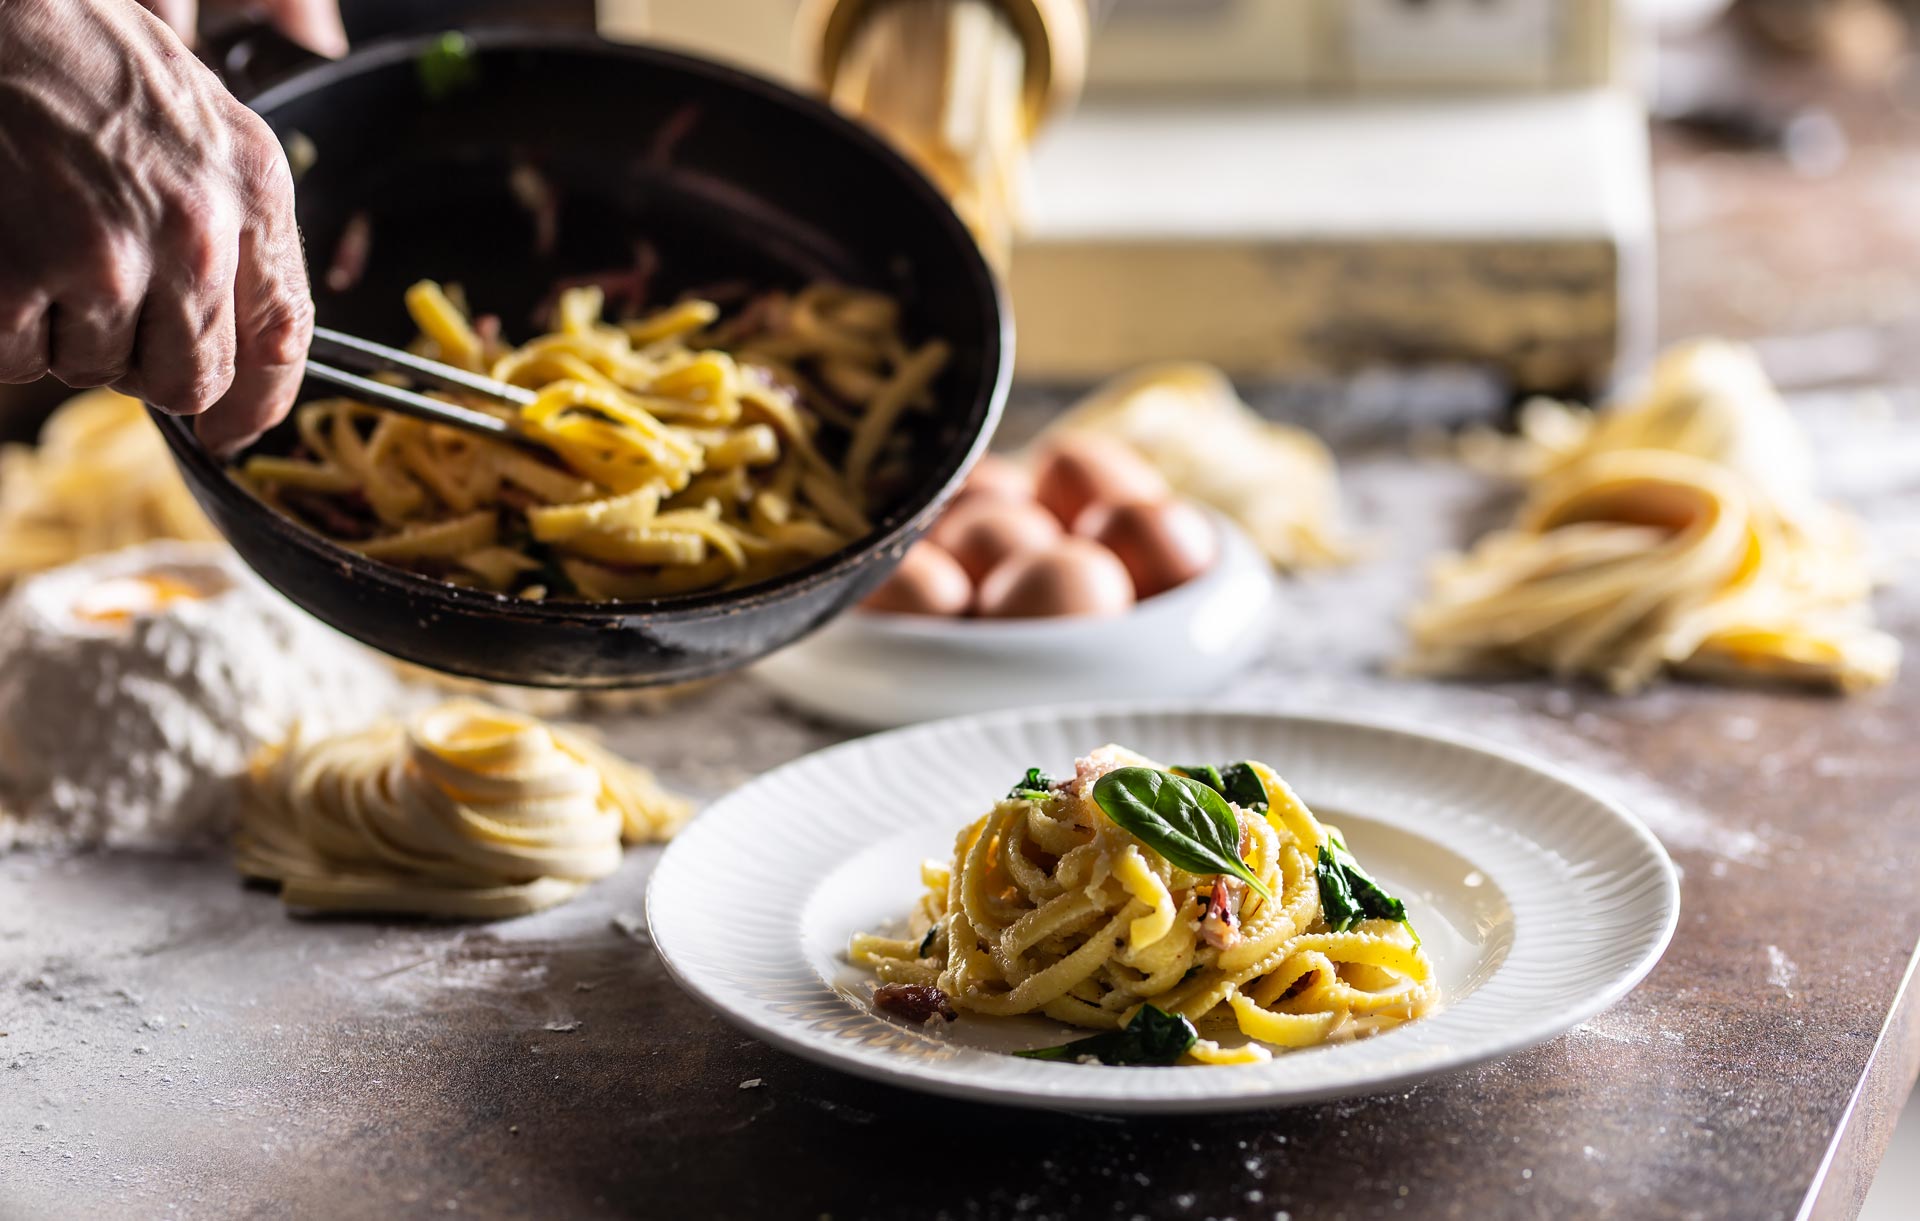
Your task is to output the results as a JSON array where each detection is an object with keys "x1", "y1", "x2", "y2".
[{"x1": 622, "y1": 0, "x2": 1651, "y2": 392}]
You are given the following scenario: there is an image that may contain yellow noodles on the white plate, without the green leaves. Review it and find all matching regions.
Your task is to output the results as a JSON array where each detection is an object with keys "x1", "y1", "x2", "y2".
[{"x1": 849, "y1": 747, "x2": 1436, "y2": 1064}]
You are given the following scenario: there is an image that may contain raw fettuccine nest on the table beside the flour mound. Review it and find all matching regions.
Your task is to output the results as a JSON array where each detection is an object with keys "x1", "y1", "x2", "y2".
[{"x1": 236, "y1": 701, "x2": 689, "y2": 918}]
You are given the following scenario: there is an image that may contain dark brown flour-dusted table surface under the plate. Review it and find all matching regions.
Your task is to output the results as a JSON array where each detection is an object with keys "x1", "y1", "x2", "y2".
[{"x1": 11, "y1": 50, "x2": 1920, "y2": 1221}]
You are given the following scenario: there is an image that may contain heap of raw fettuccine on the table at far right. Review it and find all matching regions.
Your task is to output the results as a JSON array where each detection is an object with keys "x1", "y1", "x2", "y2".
[{"x1": 1407, "y1": 342, "x2": 1899, "y2": 691}]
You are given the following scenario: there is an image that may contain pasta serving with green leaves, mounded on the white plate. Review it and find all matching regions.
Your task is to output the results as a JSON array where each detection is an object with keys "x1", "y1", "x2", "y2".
[{"x1": 849, "y1": 745, "x2": 1436, "y2": 1064}]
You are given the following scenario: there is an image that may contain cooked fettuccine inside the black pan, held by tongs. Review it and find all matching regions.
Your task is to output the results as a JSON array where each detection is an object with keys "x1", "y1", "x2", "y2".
[{"x1": 244, "y1": 282, "x2": 947, "y2": 601}]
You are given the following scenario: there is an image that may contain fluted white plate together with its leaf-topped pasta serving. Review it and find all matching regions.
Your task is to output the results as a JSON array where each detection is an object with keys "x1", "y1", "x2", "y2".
[{"x1": 647, "y1": 706, "x2": 1680, "y2": 1112}]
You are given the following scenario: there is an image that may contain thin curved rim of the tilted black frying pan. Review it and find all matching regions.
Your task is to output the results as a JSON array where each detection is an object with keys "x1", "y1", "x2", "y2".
[{"x1": 148, "y1": 25, "x2": 1014, "y2": 628}]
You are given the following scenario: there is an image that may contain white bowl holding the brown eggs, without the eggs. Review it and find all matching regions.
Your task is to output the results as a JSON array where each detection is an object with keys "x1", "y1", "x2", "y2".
[{"x1": 753, "y1": 515, "x2": 1275, "y2": 730}]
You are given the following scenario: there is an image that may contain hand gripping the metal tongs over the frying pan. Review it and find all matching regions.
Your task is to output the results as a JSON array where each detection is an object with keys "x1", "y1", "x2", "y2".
[{"x1": 0, "y1": 0, "x2": 313, "y2": 449}]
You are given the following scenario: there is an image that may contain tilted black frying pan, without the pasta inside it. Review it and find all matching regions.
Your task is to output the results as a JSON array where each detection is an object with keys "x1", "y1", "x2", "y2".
[{"x1": 159, "y1": 31, "x2": 1012, "y2": 687}]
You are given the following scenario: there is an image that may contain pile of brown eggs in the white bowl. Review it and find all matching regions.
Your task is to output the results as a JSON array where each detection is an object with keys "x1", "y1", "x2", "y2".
[{"x1": 860, "y1": 434, "x2": 1219, "y2": 618}]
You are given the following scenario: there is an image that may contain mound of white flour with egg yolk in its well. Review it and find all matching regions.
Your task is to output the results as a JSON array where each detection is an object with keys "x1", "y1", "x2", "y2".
[{"x1": 0, "y1": 543, "x2": 401, "y2": 850}]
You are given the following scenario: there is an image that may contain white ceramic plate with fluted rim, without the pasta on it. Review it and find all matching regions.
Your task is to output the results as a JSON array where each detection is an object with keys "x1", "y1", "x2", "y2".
[{"x1": 647, "y1": 708, "x2": 1680, "y2": 1112}]
